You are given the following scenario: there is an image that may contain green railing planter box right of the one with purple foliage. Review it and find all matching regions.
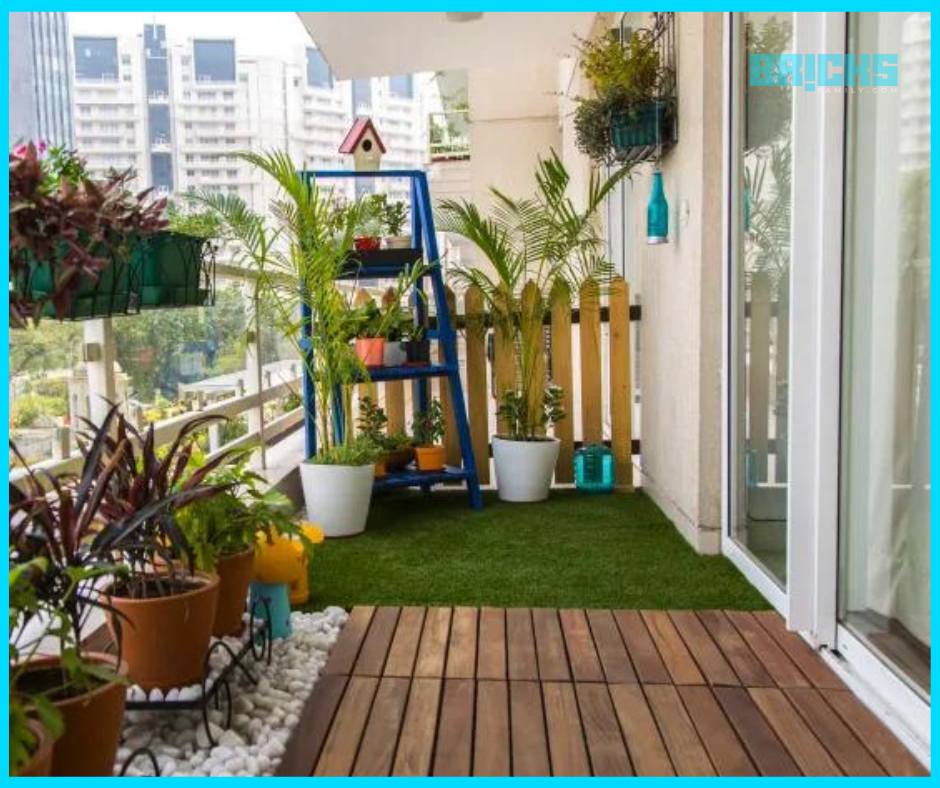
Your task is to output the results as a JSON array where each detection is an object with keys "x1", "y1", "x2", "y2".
[{"x1": 141, "y1": 232, "x2": 215, "y2": 309}]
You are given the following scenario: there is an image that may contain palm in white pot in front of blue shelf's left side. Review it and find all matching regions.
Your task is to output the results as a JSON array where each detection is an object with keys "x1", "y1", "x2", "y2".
[{"x1": 200, "y1": 152, "x2": 378, "y2": 537}]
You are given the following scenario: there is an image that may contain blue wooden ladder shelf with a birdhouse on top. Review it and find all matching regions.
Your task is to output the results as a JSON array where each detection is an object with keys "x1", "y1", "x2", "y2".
[{"x1": 302, "y1": 170, "x2": 483, "y2": 509}]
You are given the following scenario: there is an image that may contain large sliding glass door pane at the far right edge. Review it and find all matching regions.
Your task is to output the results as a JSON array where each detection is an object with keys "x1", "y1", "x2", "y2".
[{"x1": 839, "y1": 12, "x2": 930, "y2": 697}]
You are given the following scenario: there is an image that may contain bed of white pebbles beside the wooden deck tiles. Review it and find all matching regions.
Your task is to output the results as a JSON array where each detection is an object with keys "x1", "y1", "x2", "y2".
[{"x1": 115, "y1": 607, "x2": 347, "y2": 777}]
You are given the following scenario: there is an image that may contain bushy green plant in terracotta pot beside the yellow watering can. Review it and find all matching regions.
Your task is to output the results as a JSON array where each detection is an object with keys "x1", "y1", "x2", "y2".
[{"x1": 177, "y1": 448, "x2": 307, "y2": 637}]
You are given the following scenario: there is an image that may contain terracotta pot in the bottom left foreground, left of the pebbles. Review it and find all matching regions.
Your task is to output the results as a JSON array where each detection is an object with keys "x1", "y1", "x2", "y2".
[{"x1": 16, "y1": 653, "x2": 127, "y2": 777}]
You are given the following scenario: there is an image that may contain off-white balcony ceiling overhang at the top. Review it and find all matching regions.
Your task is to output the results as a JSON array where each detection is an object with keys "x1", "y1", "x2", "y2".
[{"x1": 297, "y1": 11, "x2": 597, "y2": 79}]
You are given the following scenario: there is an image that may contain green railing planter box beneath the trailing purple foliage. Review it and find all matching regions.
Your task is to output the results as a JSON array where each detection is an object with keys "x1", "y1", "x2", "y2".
[{"x1": 12, "y1": 238, "x2": 147, "y2": 320}]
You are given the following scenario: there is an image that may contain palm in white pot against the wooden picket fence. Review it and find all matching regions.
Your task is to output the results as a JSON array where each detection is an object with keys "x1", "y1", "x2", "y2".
[{"x1": 437, "y1": 151, "x2": 627, "y2": 501}]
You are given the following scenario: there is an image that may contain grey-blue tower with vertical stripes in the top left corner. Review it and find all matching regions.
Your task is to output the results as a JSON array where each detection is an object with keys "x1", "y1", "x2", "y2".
[{"x1": 9, "y1": 11, "x2": 74, "y2": 147}]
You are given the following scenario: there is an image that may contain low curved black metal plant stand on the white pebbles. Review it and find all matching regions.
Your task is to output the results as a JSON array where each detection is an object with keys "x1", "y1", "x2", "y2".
[{"x1": 125, "y1": 599, "x2": 273, "y2": 756}]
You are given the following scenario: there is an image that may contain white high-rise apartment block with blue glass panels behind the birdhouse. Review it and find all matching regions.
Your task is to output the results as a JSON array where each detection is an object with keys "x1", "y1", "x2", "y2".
[{"x1": 74, "y1": 24, "x2": 433, "y2": 209}]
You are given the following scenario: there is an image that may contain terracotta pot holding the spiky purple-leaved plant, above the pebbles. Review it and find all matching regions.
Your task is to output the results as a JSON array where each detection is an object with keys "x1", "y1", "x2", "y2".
[{"x1": 107, "y1": 572, "x2": 219, "y2": 692}]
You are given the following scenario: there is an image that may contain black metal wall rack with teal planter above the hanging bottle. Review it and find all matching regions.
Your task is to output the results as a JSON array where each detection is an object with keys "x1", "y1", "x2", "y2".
[{"x1": 610, "y1": 11, "x2": 679, "y2": 164}]
